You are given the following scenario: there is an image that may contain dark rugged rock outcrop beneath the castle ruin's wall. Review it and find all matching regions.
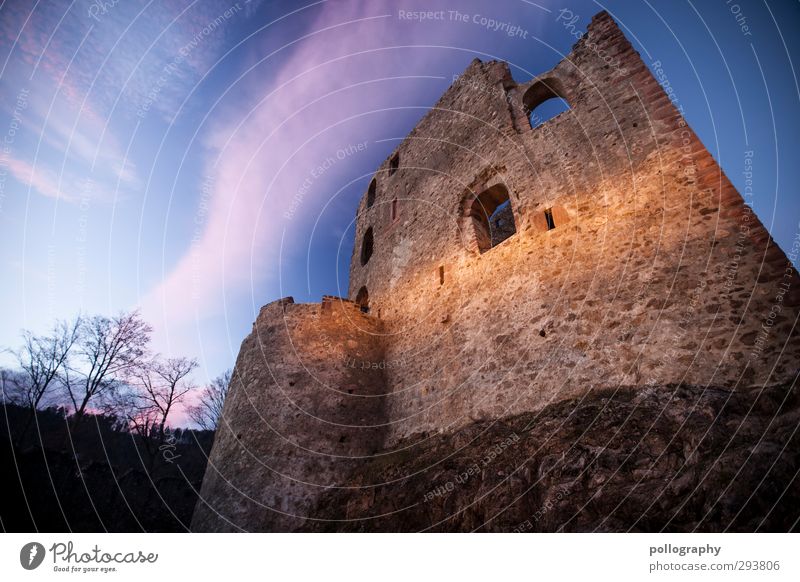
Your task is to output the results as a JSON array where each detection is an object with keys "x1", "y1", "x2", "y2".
[{"x1": 305, "y1": 385, "x2": 800, "y2": 532}]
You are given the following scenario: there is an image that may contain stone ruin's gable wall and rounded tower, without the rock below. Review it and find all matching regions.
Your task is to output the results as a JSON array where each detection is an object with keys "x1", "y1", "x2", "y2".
[{"x1": 194, "y1": 13, "x2": 800, "y2": 530}]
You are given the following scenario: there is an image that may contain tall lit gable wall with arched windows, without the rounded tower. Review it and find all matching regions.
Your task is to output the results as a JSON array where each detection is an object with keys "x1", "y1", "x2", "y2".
[{"x1": 351, "y1": 14, "x2": 798, "y2": 442}]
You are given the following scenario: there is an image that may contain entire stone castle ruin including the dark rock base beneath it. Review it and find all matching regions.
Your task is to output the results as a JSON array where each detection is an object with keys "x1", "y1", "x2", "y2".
[{"x1": 193, "y1": 12, "x2": 800, "y2": 531}]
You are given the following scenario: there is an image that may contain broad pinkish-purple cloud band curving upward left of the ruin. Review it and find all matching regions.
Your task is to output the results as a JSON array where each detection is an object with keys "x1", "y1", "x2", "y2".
[{"x1": 144, "y1": 3, "x2": 516, "y2": 324}]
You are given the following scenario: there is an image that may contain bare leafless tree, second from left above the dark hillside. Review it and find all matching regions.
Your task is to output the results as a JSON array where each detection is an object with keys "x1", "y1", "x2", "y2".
[{"x1": 62, "y1": 311, "x2": 152, "y2": 424}]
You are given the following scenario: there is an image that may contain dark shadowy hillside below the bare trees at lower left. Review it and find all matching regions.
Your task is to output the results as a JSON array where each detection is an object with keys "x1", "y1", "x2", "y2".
[{"x1": 0, "y1": 404, "x2": 213, "y2": 532}]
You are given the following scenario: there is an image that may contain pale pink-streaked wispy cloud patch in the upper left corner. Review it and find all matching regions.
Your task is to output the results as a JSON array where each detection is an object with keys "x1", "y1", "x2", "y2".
[{"x1": 0, "y1": 0, "x2": 251, "y2": 205}]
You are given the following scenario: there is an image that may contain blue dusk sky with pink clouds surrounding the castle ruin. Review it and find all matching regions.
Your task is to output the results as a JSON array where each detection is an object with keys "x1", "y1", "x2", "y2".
[{"x1": 0, "y1": 0, "x2": 800, "y2": 422}]
